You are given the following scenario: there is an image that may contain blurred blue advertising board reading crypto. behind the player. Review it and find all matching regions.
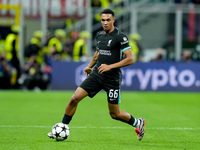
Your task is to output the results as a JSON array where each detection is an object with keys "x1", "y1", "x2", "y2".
[{"x1": 52, "y1": 61, "x2": 200, "y2": 92}]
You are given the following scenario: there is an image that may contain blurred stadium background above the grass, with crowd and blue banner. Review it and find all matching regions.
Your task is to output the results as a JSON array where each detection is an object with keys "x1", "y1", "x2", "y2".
[{"x1": 0, "y1": 0, "x2": 200, "y2": 92}]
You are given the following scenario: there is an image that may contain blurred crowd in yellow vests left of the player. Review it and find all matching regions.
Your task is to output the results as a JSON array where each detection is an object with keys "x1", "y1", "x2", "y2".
[{"x1": 0, "y1": 25, "x2": 91, "y2": 90}]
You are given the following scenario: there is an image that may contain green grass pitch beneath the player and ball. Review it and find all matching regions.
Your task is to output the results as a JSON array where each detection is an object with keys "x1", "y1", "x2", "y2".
[{"x1": 0, "y1": 91, "x2": 200, "y2": 150}]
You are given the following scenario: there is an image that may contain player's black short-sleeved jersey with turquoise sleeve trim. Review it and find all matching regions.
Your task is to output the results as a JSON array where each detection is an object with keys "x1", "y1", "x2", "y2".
[{"x1": 93, "y1": 28, "x2": 131, "y2": 80}]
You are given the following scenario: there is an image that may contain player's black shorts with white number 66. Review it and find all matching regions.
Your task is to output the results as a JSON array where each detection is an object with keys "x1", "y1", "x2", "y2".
[{"x1": 80, "y1": 74, "x2": 121, "y2": 104}]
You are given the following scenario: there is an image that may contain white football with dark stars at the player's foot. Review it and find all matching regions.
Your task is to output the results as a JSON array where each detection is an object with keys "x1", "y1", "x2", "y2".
[{"x1": 52, "y1": 123, "x2": 70, "y2": 141}]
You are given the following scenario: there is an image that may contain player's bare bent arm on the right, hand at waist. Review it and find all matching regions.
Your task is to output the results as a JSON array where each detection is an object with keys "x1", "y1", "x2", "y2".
[{"x1": 98, "y1": 49, "x2": 134, "y2": 74}]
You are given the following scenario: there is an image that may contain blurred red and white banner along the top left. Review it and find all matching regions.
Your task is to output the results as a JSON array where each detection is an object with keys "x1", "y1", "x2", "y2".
[{"x1": 0, "y1": 0, "x2": 87, "y2": 18}]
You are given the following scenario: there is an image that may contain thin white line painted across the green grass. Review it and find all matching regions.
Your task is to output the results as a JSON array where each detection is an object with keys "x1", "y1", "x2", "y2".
[{"x1": 0, "y1": 125, "x2": 200, "y2": 130}]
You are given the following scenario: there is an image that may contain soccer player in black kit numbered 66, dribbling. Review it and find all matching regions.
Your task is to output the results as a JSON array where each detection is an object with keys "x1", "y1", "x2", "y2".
[{"x1": 47, "y1": 9, "x2": 145, "y2": 140}]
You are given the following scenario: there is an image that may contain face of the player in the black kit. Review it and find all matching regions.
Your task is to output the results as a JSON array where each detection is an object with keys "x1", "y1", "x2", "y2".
[{"x1": 101, "y1": 14, "x2": 115, "y2": 33}]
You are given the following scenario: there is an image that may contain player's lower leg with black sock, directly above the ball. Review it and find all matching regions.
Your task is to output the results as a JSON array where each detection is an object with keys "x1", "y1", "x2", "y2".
[{"x1": 62, "y1": 87, "x2": 88, "y2": 124}]
